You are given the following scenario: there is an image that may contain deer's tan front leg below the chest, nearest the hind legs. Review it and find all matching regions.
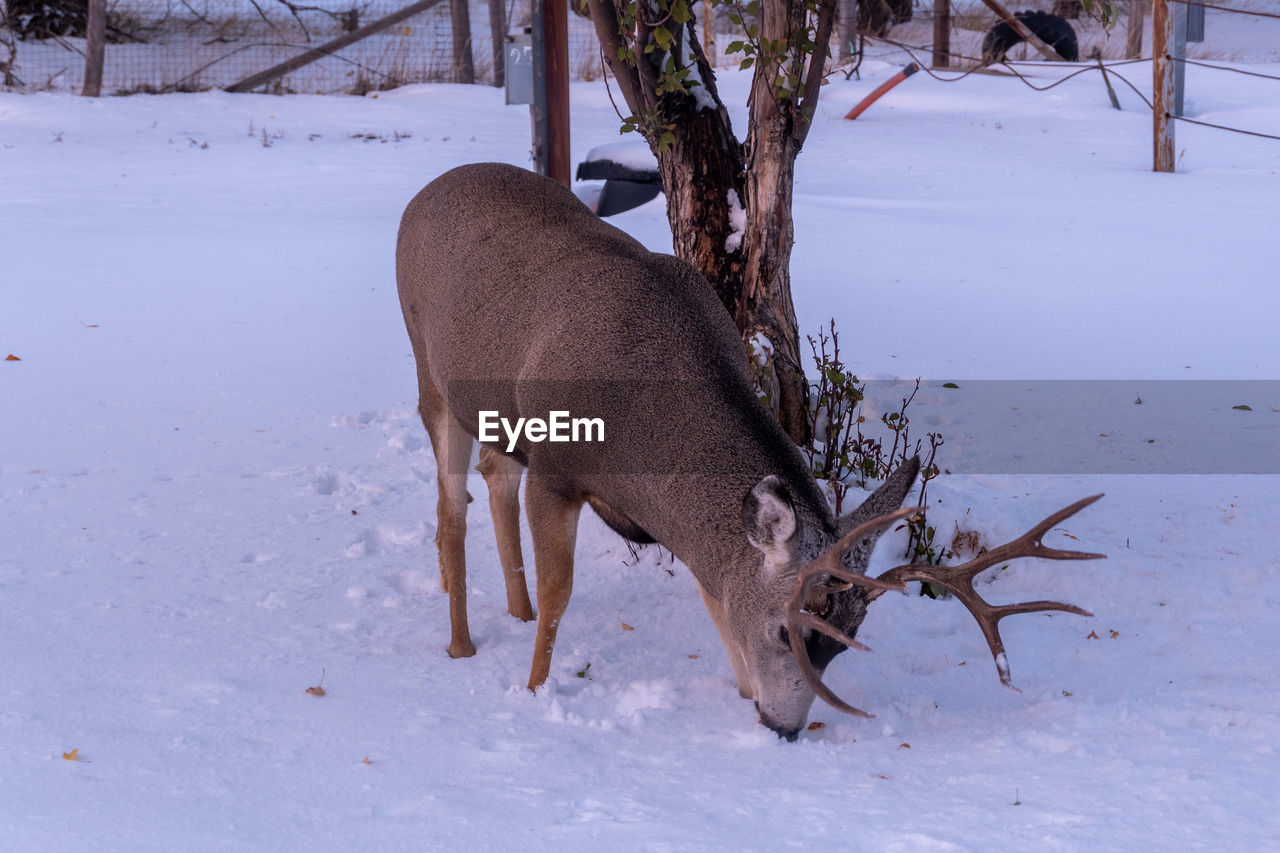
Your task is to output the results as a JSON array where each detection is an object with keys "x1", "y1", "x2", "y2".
[{"x1": 525, "y1": 473, "x2": 582, "y2": 690}]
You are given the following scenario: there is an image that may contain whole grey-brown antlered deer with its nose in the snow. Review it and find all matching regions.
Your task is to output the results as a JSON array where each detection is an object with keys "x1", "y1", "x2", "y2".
[{"x1": 396, "y1": 163, "x2": 1102, "y2": 740}]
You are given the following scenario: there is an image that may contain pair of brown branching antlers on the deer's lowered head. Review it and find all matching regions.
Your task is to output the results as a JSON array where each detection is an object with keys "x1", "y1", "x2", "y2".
[{"x1": 787, "y1": 494, "x2": 1106, "y2": 717}]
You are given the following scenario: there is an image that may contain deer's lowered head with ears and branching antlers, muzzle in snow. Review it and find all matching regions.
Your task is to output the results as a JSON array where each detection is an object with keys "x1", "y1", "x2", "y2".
[{"x1": 722, "y1": 460, "x2": 1102, "y2": 740}]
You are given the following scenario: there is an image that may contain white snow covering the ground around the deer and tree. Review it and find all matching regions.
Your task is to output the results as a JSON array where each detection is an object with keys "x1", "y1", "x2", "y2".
[{"x1": 0, "y1": 36, "x2": 1280, "y2": 850}]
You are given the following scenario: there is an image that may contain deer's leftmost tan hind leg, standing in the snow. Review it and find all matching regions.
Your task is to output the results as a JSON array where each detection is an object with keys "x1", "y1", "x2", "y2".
[{"x1": 419, "y1": 371, "x2": 476, "y2": 657}]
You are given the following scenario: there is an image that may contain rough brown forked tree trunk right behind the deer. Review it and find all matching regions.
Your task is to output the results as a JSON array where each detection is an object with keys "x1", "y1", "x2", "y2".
[{"x1": 590, "y1": 0, "x2": 836, "y2": 442}]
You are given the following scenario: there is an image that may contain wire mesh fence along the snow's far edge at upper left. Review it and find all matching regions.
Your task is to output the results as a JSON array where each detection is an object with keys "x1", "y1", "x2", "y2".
[{"x1": 0, "y1": 0, "x2": 598, "y2": 93}]
